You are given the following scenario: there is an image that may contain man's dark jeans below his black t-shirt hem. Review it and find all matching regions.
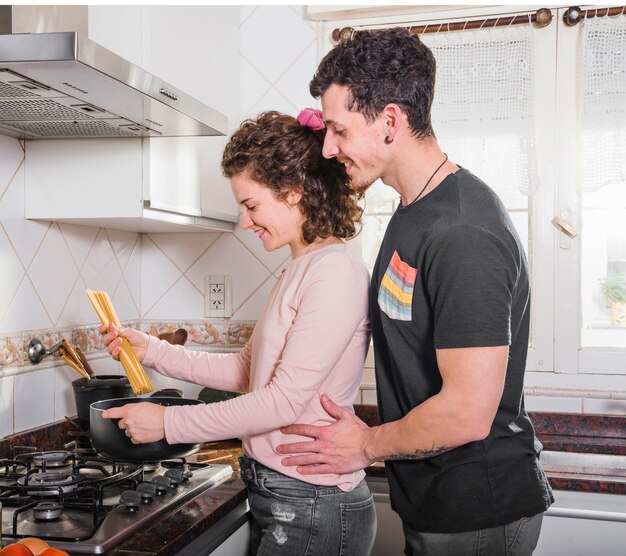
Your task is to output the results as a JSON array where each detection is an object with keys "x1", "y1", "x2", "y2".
[{"x1": 404, "y1": 513, "x2": 543, "y2": 556}]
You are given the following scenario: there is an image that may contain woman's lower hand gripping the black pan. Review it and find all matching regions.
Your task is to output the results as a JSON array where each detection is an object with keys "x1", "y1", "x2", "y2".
[{"x1": 102, "y1": 402, "x2": 165, "y2": 444}]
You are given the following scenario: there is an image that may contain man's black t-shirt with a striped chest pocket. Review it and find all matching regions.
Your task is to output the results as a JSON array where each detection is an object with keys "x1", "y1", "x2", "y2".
[{"x1": 370, "y1": 169, "x2": 553, "y2": 533}]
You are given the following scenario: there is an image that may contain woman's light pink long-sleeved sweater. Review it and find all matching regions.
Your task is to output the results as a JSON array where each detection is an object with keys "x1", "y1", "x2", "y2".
[{"x1": 142, "y1": 244, "x2": 370, "y2": 490}]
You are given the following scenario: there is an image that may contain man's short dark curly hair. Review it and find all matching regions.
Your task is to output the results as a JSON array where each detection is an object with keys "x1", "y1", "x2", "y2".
[{"x1": 309, "y1": 27, "x2": 436, "y2": 139}]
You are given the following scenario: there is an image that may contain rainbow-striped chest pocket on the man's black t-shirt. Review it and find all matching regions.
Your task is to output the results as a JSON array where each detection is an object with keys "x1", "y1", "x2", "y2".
[{"x1": 378, "y1": 251, "x2": 417, "y2": 320}]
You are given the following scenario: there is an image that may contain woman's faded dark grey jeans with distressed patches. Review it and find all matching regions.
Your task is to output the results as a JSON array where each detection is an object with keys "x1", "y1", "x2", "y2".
[{"x1": 239, "y1": 456, "x2": 376, "y2": 556}]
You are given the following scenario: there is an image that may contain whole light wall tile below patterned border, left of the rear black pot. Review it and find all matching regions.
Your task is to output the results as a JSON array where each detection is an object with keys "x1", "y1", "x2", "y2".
[{"x1": 15, "y1": 369, "x2": 55, "y2": 432}]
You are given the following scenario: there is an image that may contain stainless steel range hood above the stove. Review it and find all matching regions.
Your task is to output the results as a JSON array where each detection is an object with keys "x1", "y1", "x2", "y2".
[{"x1": 0, "y1": 5, "x2": 228, "y2": 139}]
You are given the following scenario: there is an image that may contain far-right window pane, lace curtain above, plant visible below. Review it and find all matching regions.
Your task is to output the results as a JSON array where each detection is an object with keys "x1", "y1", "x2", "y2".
[{"x1": 580, "y1": 17, "x2": 626, "y2": 348}]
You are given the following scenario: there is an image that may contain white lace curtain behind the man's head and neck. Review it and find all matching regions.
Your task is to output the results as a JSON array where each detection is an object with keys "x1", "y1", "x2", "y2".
[{"x1": 421, "y1": 25, "x2": 538, "y2": 194}]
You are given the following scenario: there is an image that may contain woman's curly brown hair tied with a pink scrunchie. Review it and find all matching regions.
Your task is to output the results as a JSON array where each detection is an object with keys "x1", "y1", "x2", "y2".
[{"x1": 222, "y1": 112, "x2": 363, "y2": 243}]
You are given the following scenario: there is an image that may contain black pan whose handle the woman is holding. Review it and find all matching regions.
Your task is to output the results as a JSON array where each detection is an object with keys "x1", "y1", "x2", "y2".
[{"x1": 89, "y1": 397, "x2": 202, "y2": 463}]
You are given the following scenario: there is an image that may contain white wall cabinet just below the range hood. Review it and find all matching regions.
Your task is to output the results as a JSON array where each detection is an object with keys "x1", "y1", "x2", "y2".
[{"x1": 24, "y1": 137, "x2": 238, "y2": 232}]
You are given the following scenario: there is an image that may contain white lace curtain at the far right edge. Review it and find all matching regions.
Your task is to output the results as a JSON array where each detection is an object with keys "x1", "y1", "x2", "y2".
[{"x1": 579, "y1": 15, "x2": 626, "y2": 192}]
